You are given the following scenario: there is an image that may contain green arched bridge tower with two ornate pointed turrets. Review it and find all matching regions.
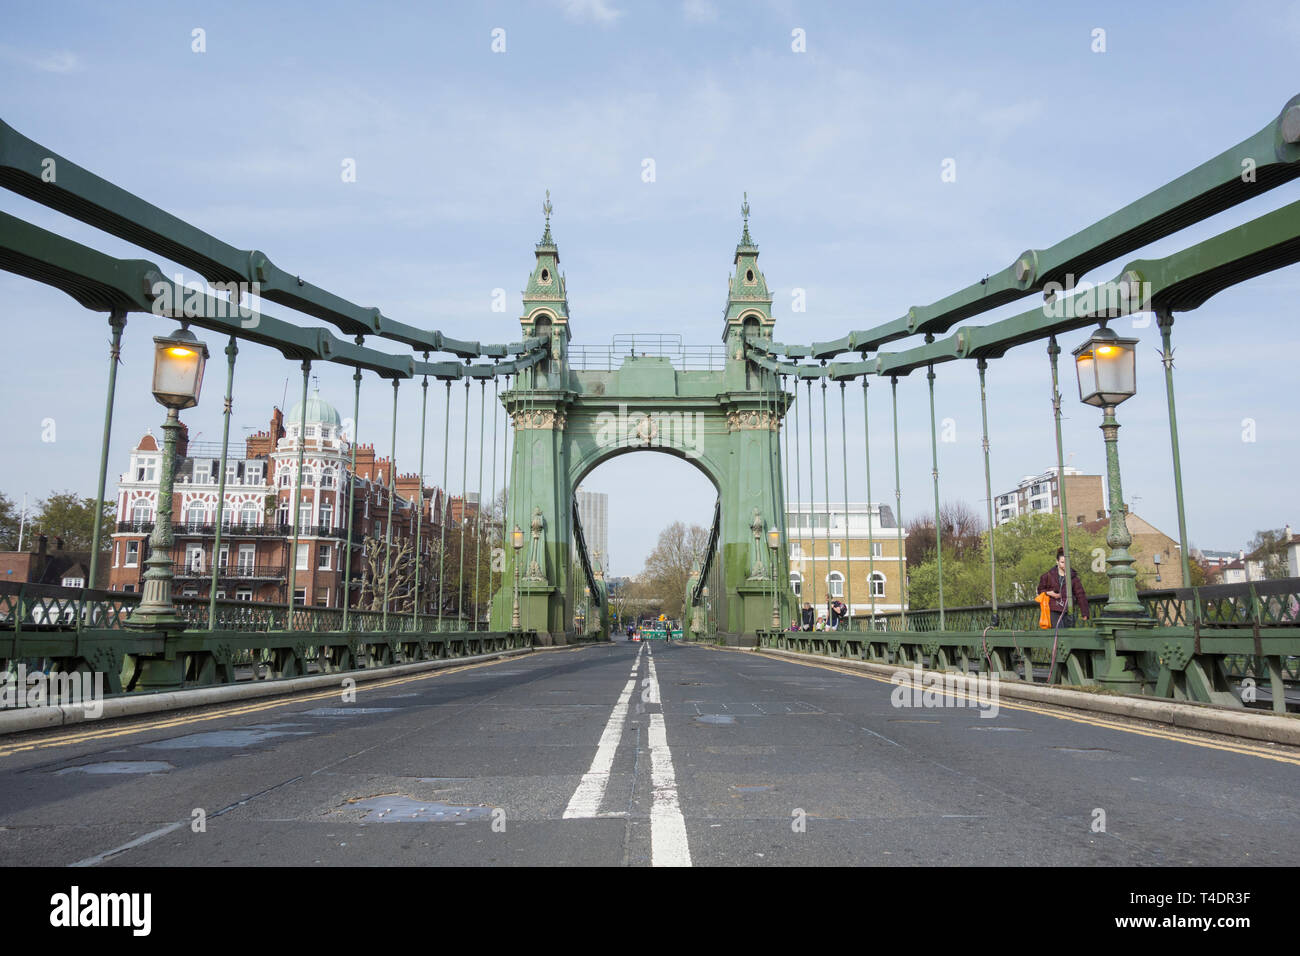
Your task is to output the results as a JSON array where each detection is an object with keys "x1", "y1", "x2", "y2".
[{"x1": 491, "y1": 196, "x2": 788, "y2": 643}]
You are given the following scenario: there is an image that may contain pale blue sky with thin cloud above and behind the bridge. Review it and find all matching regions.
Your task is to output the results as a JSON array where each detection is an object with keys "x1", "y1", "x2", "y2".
[{"x1": 0, "y1": 0, "x2": 1300, "y2": 574}]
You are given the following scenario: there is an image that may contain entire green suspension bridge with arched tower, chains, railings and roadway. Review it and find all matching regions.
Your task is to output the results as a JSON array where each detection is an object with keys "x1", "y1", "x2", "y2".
[{"x1": 0, "y1": 96, "x2": 1300, "y2": 865}]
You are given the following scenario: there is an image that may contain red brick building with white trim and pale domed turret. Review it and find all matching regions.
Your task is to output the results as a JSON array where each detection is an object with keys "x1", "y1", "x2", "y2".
[{"x1": 109, "y1": 392, "x2": 442, "y2": 610}]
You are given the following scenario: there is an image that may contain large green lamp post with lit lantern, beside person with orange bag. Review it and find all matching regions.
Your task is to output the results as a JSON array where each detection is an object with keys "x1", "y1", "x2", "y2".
[{"x1": 1066, "y1": 324, "x2": 1147, "y2": 620}]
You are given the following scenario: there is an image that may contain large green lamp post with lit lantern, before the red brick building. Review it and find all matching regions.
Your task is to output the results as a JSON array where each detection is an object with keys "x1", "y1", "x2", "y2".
[{"x1": 126, "y1": 326, "x2": 208, "y2": 628}]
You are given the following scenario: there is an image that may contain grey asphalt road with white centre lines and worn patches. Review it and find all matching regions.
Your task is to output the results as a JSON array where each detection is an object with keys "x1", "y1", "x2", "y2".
[{"x1": 0, "y1": 641, "x2": 1300, "y2": 866}]
